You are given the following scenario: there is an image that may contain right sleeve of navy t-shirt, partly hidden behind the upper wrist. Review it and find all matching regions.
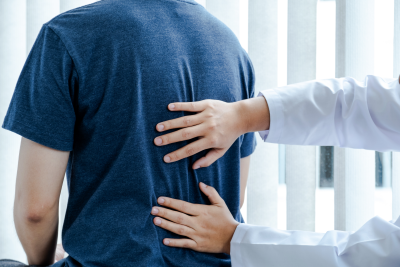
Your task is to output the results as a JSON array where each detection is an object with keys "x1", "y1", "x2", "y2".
[{"x1": 240, "y1": 55, "x2": 257, "y2": 158}]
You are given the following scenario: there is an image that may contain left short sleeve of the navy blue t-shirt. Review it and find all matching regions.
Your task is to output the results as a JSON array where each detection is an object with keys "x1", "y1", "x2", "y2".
[{"x1": 3, "y1": 25, "x2": 78, "y2": 151}]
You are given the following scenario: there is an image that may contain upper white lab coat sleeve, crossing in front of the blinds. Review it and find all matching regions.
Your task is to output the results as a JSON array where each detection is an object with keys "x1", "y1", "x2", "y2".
[{"x1": 260, "y1": 76, "x2": 400, "y2": 151}]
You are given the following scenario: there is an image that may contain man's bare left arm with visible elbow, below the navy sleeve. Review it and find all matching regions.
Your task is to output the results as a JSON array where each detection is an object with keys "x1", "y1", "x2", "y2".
[{"x1": 14, "y1": 138, "x2": 69, "y2": 266}]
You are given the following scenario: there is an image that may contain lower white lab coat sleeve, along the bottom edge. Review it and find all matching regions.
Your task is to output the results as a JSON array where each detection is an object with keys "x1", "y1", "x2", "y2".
[{"x1": 231, "y1": 217, "x2": 400, "y2": 267}]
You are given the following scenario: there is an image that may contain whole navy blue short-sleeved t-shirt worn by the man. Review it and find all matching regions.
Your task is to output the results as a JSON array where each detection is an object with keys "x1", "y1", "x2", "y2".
[{"x1": 3, "y1": 0, "x2": 255, "y2": 267}]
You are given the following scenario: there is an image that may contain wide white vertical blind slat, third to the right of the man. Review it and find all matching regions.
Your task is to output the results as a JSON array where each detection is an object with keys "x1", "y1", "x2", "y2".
[{"x1": 334, "y1": 0, "x2": 375, "y2": 231}]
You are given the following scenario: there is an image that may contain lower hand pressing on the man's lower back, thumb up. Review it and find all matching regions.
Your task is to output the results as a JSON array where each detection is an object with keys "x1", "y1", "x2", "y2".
[{"x1": 151, "y1": 183, "x2": 239, "y2": 254}]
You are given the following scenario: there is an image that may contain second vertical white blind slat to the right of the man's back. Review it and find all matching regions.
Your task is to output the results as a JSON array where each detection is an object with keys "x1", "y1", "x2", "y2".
[{"x1": 286, "y1": 0, "x2": 317, "y2": 231}]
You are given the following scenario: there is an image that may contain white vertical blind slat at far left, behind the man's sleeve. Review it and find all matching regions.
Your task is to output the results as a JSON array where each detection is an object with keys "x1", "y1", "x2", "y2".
[{"x1": 0, "y1": 0, "x2": 26, "y2": 262}]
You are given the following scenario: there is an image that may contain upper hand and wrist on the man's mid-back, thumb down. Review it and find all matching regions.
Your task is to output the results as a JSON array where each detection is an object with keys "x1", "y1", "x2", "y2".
[{"x1": 154, "y1": 97, "x2": 270, "y2": 169}]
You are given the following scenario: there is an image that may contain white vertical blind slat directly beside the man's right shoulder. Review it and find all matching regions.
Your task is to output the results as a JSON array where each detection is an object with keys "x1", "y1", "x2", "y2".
[{"x1": 247, "y1": 0, "x2": 279, "y2": 227}]
